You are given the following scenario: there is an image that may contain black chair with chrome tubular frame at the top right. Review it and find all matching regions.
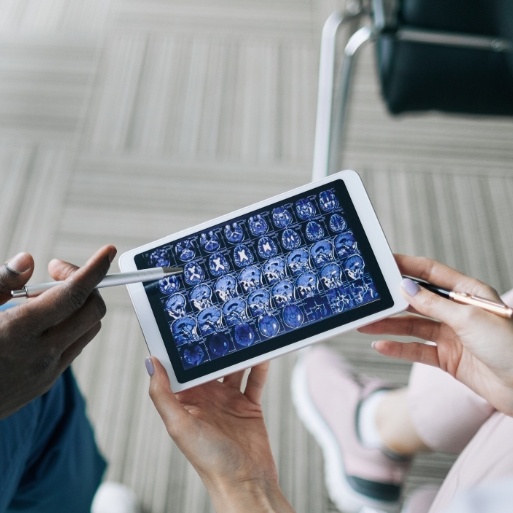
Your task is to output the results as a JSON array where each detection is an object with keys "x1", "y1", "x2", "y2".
[{"x1": 312, "y1": 0, "x2": 513, "y2": 180}]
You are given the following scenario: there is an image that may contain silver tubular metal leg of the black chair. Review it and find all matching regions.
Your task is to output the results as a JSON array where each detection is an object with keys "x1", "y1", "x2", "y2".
[{"x1": 312, "y1": 19, "x2": 374, "y2": 181}]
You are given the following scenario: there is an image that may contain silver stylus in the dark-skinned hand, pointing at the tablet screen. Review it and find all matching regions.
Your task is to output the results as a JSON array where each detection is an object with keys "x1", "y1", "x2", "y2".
[{"x1": 11, "y1": 267, "x2": 183, "y2": 298}]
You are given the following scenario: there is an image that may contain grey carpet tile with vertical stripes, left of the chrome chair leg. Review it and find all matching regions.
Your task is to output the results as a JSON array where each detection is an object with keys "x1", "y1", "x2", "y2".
[{"x1": 82, "y1": 34, "x2": 316, "y2": 163}]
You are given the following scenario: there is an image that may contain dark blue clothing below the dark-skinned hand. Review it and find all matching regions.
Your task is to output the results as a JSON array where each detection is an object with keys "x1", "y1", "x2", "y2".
[{"x1": 0, "y1": 369, "x2": 106, "y2": 513}]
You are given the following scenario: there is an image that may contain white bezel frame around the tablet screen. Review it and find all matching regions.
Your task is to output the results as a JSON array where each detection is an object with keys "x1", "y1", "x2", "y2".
[{"x1": 119, "y1": 171, "x2": 407, "y2": 392}]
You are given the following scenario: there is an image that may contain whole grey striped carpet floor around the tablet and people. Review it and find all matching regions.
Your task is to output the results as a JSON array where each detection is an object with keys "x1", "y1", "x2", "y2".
[{"x1": 0, "y1": 0, "x2": 513, "y2": 513}]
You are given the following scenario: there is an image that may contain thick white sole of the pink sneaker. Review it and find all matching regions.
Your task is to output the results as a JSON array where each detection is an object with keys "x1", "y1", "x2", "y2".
[{"x1": 291, "y1": 355, "x2": 400, "y2": 513}]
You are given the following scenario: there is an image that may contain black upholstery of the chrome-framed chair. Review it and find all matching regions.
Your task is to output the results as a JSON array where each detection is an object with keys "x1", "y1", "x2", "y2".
[{"x1": 376, "y1": 0, "x2": 513, "y2": 116}]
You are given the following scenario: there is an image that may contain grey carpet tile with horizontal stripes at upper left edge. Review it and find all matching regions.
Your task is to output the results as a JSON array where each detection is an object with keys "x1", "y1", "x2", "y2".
[{"x1": 0, "y1": 35, "x2": 98, "y2": 143}]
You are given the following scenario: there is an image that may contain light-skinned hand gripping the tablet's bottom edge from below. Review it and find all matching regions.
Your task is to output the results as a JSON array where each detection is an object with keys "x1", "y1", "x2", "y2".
[{"x1": 146, "y1": 357, "x2": 292, "y2": 513}]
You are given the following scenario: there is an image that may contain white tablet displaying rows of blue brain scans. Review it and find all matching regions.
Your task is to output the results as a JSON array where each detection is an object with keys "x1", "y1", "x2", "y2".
[{"x1": 119, "y1": 171, "x2": 407, "y2": 392}]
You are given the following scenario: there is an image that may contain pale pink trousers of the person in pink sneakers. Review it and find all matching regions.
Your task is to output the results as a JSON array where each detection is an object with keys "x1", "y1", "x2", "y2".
[{"x1": 408, "y1": 364, "x2": 513, "y2": 513}]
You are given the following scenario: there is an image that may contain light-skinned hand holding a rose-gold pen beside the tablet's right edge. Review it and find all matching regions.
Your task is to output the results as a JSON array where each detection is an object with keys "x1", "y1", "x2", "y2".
[{"x1": 359, "y1": 255, "x2": 513, "y2": 415}]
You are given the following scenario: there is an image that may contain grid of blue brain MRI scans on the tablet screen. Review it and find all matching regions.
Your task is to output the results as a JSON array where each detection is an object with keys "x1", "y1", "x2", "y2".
[{"x1": 136, "y1": 184, "x2": 379, "y2": 370}]
